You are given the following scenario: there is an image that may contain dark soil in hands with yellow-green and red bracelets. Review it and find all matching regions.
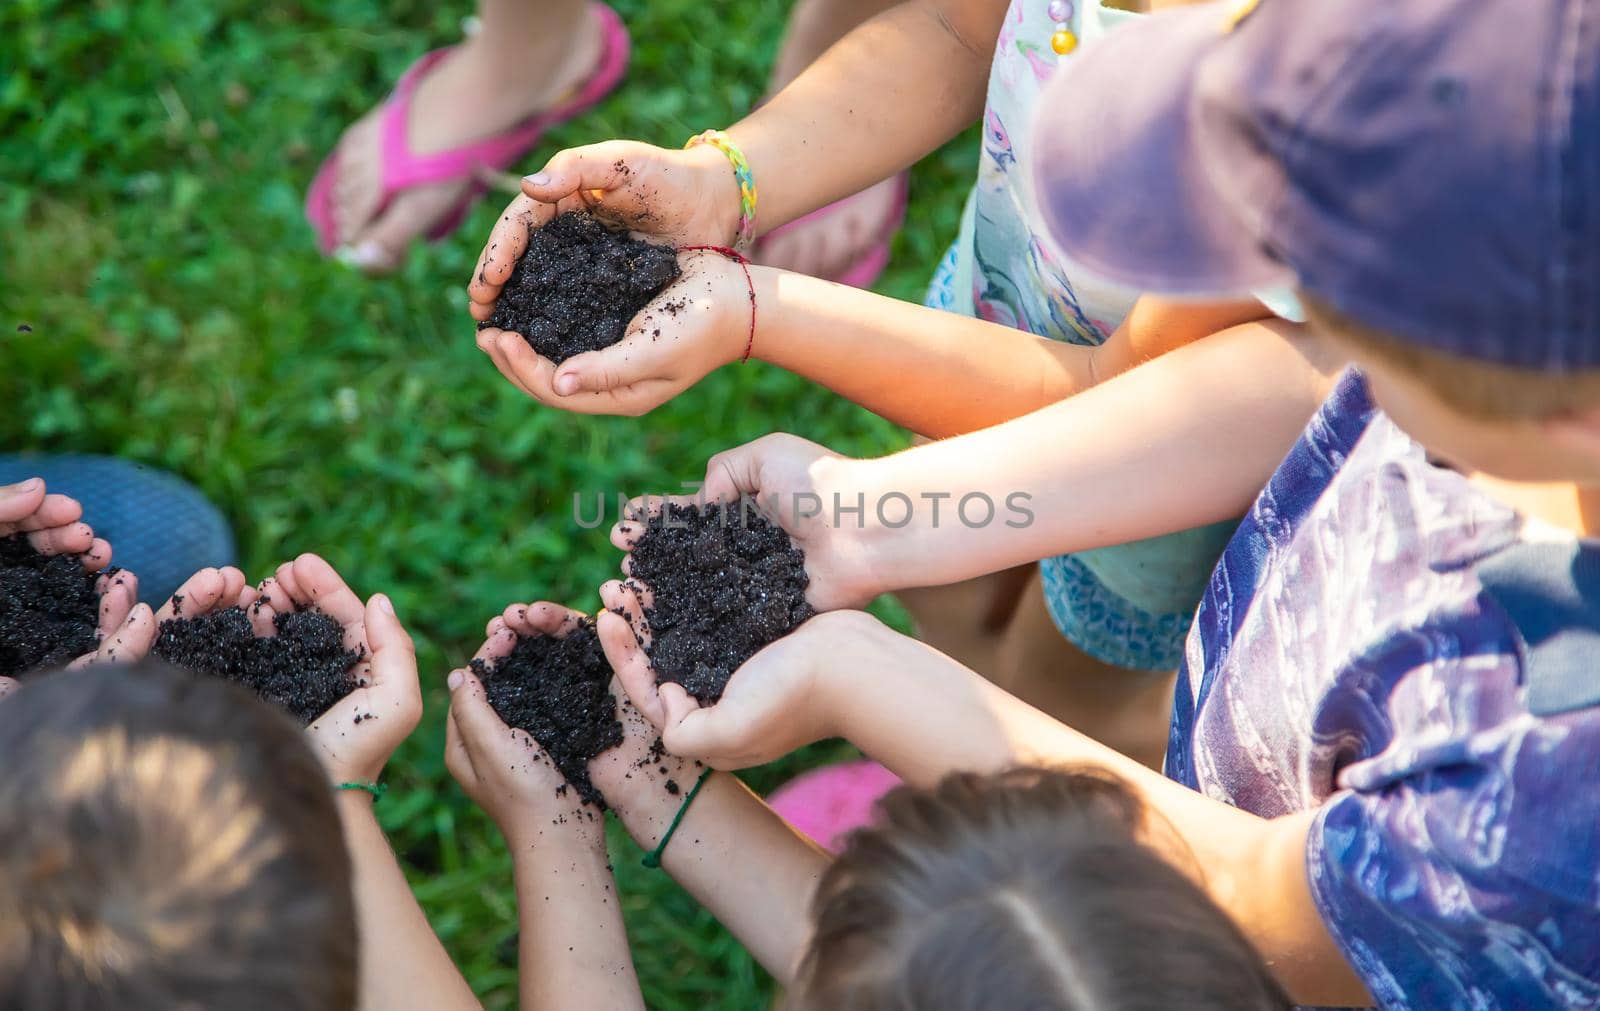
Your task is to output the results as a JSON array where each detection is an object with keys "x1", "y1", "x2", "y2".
[{"x1": 478, "y1": 211, "x2": 678, "y2": 365}]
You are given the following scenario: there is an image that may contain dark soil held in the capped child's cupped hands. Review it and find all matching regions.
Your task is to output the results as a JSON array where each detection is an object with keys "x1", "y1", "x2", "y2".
[{"x1": 617, "y1": 504, "x2": 816, "y2": 705}]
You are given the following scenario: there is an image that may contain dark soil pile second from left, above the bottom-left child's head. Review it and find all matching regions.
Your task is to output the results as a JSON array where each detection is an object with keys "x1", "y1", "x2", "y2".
[{"x1": 155, "y1": 608, "x2": 361, "y2": 725}]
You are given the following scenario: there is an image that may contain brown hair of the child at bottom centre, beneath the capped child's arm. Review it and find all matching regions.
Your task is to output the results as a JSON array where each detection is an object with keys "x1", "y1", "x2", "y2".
[{"x1": 790, "y1": 769, "x2": 1290, "y2": 1011}]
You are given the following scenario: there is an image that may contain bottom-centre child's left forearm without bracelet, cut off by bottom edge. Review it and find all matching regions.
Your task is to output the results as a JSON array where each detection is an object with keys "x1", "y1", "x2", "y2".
[{"x1": 507, "y1": 829, "x2": 645, "y2": 1011}]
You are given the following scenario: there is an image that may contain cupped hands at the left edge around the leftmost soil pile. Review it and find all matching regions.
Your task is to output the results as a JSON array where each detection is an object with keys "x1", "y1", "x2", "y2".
[{"x1": 0, "y1": 478, "x2": 155, "y2": 687}]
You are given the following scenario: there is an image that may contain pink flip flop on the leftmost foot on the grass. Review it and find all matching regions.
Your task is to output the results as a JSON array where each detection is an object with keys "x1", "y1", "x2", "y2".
[{"x1": 306, "y1": 3, "x2": 629, "y2": 256}]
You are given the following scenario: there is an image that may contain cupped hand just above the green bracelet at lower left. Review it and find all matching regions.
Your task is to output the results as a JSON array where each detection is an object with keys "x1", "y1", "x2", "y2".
[{"x1": 262, "y1": 553, "x2": 422, "y2": 784}]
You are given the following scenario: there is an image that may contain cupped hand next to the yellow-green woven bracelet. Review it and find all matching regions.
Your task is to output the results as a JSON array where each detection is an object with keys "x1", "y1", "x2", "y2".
[{"x1": 467, "y1": 141, "x2": 739, "y2": 323}]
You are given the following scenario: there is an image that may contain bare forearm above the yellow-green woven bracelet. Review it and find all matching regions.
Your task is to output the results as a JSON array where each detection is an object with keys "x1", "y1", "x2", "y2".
[{"x1": 728, "y1": 0, "x2": 1006, "y2": 232}]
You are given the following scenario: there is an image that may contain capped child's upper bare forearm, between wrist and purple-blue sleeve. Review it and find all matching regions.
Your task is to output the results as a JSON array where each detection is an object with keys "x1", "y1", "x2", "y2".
[{"x1": 837, "y1": 316, "x2": 1336, "y2": 592}]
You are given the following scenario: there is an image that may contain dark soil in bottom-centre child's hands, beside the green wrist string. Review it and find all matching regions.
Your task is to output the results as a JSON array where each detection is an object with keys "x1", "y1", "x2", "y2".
[{"x1": 472, "y1": 621, "x2": 622, "y2": 811}]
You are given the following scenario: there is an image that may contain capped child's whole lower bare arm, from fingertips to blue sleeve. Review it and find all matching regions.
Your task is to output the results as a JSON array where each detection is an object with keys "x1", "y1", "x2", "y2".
[{"x1": 600, "y1": 606, "x2": 1371, "y2": 1006}]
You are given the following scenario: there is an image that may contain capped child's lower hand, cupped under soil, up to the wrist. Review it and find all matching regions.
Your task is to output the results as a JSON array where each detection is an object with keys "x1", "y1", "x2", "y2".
[{"x1": 598, "y1": 582, "x2": 891, "y2": 769}]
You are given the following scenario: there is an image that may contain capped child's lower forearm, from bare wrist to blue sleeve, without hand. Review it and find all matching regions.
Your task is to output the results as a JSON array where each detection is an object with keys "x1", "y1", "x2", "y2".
[{"x1": 819, "y1": 616, "x2": 1370, "y2": 1006}]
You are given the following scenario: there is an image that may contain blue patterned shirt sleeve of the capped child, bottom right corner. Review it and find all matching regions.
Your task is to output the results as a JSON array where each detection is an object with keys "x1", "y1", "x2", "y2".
[{"x1": 1307, "y1": 710, "x2": 1600, "y2": 1009}]
